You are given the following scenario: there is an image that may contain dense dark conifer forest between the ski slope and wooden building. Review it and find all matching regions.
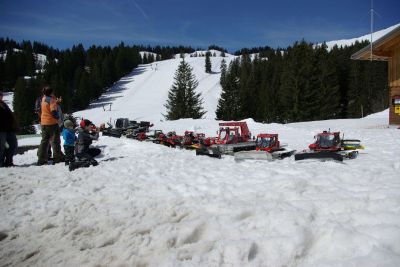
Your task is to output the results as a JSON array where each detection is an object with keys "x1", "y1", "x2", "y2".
[{"x1": 216, "y1": 41, "x2": 388, "y2": 123}]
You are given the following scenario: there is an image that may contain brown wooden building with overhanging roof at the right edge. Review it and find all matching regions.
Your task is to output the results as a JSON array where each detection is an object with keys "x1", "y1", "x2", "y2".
[{"x1": 351, "y1": 26, "x2": 400, "y2": 125}]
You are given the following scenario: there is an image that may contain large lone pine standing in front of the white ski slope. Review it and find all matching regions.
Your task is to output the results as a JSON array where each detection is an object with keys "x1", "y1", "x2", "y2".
[{"x1": 164, "y1": 60, "x2": 206, "y2": 120}]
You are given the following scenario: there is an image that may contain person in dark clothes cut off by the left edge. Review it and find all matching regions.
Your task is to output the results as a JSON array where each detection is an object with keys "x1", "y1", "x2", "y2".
[{"x1": 0, "y1": 91, "x2": 18, "y2": 167}]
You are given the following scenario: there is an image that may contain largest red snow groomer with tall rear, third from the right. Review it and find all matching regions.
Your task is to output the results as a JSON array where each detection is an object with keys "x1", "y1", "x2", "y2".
[{"x1": 196, "y1": 122, "x2": 256, "y2": 158}]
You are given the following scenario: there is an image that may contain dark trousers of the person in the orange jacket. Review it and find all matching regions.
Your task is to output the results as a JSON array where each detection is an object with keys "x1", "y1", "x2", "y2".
[{"x1": 38, "y1": 124, "x2": 62, "y2": 164}]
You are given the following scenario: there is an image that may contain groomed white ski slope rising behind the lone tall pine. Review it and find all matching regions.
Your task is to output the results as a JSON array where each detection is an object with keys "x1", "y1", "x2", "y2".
[{"x1": 75, "y1": 50, "x2": 234, "y2": 123}]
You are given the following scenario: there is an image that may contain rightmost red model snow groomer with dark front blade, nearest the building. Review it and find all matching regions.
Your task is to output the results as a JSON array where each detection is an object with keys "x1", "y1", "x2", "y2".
[{"x1": 294, "y1": 131, "x2": 358, "y2": 161}]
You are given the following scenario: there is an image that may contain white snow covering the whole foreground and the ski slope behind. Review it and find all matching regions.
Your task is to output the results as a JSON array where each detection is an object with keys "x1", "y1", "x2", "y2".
[{"x1": 0, "y1": 47, "x2": 400, "y2": 266}]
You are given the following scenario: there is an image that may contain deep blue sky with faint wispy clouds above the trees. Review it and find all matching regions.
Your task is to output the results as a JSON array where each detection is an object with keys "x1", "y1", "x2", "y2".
[{"x1": 0, "y1": 0, "x2": 400, "y2": 51}]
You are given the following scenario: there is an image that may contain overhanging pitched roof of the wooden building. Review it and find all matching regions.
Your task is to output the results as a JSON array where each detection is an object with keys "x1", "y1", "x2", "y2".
[{"x1": 351, "y1": 26, "x2": 400, "y2": 61}]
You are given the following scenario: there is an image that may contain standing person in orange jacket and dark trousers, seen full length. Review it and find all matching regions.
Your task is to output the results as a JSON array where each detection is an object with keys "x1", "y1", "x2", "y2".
[{"x1": 37, "y1": 86, "x2": 62, "y2": 165}]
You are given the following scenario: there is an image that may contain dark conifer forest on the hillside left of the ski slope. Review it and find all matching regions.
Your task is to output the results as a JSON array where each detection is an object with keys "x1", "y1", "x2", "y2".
[{"x1": 0, "y1": 38, "x2": 216, "y2": 132}]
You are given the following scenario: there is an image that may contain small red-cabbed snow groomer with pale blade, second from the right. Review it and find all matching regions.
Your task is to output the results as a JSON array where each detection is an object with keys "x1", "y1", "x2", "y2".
[{"x1": 235, "y1": 133, "x2": 295, "y2": 161}]
